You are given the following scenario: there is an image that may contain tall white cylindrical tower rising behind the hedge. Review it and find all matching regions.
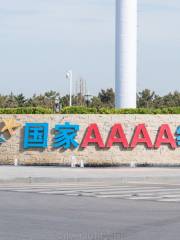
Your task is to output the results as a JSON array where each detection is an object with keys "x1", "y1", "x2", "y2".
[{"x1": 115, "y1": 0, "x2": 138, "y2": 108}]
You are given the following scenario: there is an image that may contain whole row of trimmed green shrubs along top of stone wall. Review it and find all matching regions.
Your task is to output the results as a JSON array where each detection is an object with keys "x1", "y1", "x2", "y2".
[{"x1": 0, "y1": 107, "x2": 180, "y2": 114}]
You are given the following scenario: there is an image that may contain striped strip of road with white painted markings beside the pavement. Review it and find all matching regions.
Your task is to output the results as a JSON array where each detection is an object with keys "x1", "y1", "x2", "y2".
[{"x1": 0, "y1": 181, "x2": 180, "y2": 202}]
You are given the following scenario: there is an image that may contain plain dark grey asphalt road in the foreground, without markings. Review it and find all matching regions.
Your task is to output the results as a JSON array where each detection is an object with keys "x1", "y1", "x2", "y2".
[{"x1": 0, "y1": 191, "x2": 180, "y2": 240}]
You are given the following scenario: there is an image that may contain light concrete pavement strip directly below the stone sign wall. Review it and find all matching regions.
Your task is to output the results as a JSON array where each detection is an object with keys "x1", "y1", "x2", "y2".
[{"x1": 0, "y1": 166, "x2": 180, "y2": 184}]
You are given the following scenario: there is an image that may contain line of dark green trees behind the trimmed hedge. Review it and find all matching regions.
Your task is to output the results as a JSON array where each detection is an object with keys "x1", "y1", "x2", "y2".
[{"x1": 0, "y1": 88, "x2": 180, "y2": 109}]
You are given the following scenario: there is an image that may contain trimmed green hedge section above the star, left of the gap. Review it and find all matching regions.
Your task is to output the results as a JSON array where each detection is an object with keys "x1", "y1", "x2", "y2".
[{"x1": 0, "y1": 107, "x2": 53, "y2": 114}]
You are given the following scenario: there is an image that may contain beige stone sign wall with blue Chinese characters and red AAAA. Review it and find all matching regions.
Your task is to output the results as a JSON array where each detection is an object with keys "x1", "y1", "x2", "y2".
[{"x1": 0, "y1": 115, "x2": 180, "y2": 166}]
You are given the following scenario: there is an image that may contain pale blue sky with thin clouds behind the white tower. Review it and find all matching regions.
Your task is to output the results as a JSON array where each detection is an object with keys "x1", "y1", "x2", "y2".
[{"x1": 0, "y1": 0, "x2": 180, "y2": 96}]
